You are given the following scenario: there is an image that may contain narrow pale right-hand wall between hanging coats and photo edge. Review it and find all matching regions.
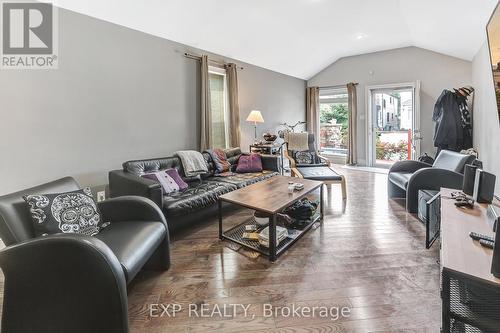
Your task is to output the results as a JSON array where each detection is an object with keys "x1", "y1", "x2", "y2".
[{"x1": 472, "y1": 42, "x2": 500, "y2": 195}]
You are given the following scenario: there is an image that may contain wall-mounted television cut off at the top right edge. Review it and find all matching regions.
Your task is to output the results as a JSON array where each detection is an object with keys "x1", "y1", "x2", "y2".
[{"x1": 486, "y1": 4, "x2": 500, "y2": 122}]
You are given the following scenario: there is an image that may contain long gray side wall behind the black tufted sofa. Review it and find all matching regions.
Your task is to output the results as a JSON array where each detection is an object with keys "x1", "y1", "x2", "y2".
[{"x1": 0, "y1": 9, "x2": 305, "y2": 194}]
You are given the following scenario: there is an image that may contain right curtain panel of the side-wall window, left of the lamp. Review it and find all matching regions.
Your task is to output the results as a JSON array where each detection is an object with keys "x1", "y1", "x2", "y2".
[{"x1": 226, "y1": 64, "x2": 241, "y2": 147}]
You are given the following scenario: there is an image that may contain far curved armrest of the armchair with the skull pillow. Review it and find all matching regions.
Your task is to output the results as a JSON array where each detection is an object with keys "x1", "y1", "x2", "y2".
[{"x1": 97, "y1": 196, "x2": 168, "y2": 230}]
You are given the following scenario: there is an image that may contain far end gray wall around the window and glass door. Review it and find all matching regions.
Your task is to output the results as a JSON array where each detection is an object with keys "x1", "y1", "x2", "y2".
[{"x1": 307, "y1": 47, "x2": 472, "y2": 164}]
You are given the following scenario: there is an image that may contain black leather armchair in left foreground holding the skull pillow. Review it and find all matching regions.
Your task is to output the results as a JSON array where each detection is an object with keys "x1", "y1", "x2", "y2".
[{"x1": 0, "y1": 177, "x2": 170, "y2": 333}]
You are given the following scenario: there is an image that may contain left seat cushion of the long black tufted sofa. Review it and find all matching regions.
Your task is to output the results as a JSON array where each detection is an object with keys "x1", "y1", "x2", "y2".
[{"x1": 163, "y1": 180, "x2": 236, "y2": 218}]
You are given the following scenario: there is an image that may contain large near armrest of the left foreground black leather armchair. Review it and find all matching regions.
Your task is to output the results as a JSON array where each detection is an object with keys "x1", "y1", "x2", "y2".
[{"x1": 0, "y1": 234, "x2": 128, "y2": 333}]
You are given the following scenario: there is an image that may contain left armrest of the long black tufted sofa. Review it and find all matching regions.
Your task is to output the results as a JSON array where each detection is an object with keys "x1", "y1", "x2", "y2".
[{"x1": 109, "y1": 170, "x2": 163, "y2": 208}]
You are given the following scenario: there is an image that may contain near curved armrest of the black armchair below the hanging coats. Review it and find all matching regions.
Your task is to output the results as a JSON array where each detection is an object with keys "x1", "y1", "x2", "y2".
[{"x1": 406, "y1": 168, "x2": 463, "y2": 213}]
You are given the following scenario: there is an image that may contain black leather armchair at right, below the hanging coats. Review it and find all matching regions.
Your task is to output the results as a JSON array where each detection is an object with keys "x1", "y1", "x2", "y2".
[{"x1": 387, "y1": 150, "x2": 475, "y2": 213}]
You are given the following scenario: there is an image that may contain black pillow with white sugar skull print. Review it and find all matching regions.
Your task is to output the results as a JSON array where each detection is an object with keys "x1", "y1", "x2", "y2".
[{"x1": 23, "y1": 187, "x2": 103, "y2": 236}]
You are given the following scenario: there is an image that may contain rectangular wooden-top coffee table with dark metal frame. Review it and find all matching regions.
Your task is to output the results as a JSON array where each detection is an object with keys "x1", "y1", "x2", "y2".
[{"x1": 219, "y1": 176, "x2": 323, "y2": 261}]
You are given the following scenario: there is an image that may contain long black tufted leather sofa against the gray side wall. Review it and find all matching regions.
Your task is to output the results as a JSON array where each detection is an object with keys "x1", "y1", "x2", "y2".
[{"x1": 109, "y1": 148, "x2": 279, "y2": 233}]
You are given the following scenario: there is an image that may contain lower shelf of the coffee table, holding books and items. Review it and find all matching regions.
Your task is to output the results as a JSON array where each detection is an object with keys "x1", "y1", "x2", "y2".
[{"x1": 221, "y1": 212, "x2": 321, "y2": 260}]
